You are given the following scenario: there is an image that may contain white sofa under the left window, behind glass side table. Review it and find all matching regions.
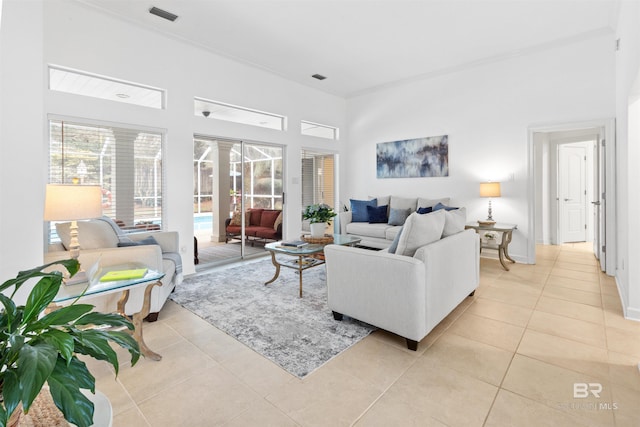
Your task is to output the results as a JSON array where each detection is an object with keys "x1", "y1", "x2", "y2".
[{"x1": 44, "y1": 217, "x2": 182, "y2": 321}]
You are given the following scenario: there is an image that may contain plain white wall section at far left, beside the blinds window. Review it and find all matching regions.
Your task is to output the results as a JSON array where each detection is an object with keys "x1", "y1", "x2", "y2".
[{"x1": 0, "y1": 1, "x2": 46, "y2": 290}]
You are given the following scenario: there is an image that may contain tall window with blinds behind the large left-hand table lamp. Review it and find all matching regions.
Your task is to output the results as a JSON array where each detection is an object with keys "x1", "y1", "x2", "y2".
[{"x1": 49, "y1": 120, "x2": 164, "y2": 236}]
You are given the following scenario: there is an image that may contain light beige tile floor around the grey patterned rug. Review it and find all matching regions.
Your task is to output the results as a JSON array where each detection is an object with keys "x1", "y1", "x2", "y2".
[{"x1": 90, "y1": 245, "x2": 640, "y2": 427}]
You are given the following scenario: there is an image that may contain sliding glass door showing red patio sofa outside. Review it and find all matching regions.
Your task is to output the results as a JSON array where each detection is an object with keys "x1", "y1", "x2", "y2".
[{"x1": 194, "y1": 137, "x2": 284, "y2": 266}]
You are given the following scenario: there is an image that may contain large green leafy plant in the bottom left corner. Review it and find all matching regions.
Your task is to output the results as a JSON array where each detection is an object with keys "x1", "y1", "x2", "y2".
[{"x1": 0, "y1": 259, "x2": 140, "y2": 427}]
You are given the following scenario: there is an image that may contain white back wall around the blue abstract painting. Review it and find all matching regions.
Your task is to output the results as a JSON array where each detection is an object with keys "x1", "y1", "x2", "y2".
[{"x1": 340, "y1": 35, "x2": 615, "y2": 262}]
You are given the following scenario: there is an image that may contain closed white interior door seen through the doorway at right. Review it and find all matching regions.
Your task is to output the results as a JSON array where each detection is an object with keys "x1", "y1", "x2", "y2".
[{"x1": 558, "y1": 144, "x2": 587, "y2": 243}]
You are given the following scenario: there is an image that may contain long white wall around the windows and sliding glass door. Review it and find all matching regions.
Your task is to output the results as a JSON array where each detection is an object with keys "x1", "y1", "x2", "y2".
[{"x1": 0, "y1": 0, "x2": 346, "y2": 284}]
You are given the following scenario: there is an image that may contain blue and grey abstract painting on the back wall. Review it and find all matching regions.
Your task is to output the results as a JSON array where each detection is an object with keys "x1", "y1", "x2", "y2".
[{"x1": 376, "y1": 135, "x2": 449, "y2": 178}]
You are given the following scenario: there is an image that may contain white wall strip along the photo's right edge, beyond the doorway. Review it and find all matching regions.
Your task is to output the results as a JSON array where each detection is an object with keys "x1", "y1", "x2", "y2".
[{"x1": 615, "y1": 2, "x2": 640, "y2": 320}]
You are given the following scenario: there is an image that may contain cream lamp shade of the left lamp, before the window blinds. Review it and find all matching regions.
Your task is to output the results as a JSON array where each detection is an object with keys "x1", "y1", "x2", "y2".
[{"x1": 44, "y1": 184, "x2": 102, "y2": 221}]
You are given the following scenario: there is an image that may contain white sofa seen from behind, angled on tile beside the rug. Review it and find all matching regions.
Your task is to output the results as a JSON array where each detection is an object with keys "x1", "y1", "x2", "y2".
[{"x1": 324, "y1": 212, "x2": 480, "y2": 350}]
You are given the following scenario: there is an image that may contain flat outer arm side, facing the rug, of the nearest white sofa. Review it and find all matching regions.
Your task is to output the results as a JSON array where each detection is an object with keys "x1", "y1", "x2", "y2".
[{"x1": 324, "y1": 245, "x2": 426, "y2": 341}]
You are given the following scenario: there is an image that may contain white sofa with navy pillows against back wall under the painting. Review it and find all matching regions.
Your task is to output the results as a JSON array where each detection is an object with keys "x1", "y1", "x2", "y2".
[{"x1": 337, "y1": 195, "x2": 450, "y2": 249}]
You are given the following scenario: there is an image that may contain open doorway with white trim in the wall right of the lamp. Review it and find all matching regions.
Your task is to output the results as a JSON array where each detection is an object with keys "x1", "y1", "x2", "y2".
[{"x1": 528, "y1": 120, "x2": 615, "y2": 274}]
